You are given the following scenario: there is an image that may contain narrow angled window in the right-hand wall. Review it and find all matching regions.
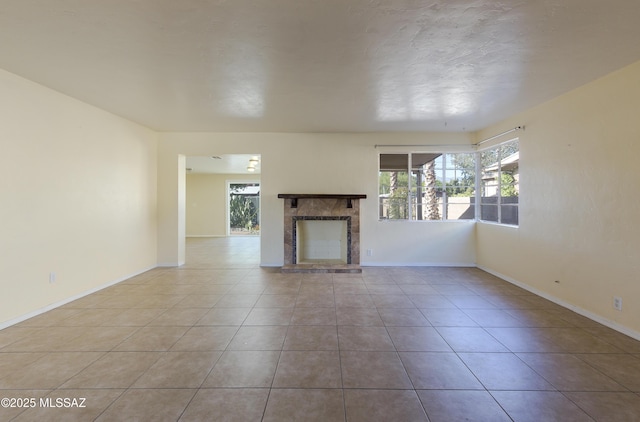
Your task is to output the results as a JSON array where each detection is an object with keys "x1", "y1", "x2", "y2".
[{"x1": 479, "y1": 140, "x2": 520, "y2": 225}]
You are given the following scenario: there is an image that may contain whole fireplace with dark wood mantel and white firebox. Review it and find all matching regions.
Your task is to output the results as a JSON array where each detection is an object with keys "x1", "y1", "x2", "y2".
[{"x1": 278, "y1": 194, "x2": 366, "y2": 272}]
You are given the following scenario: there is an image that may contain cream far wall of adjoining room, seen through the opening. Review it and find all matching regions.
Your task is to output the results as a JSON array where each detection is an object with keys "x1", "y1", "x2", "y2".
[{"x1": 186, "y1": 173, "x2": 260, "y2": 237}]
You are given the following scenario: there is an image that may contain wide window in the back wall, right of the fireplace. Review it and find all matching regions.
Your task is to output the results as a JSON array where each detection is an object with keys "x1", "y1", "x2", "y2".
[{"x1": 379, "y1": 153, "x2": 476, "y2": 220}]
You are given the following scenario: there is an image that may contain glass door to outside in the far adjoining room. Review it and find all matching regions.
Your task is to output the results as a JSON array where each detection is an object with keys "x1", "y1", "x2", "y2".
[{"x1": 227, "y1": 180, "x2": 260, "y2": 236}]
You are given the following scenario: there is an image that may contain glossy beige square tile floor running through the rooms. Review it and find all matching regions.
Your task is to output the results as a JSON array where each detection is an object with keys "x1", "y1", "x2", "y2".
[{"x1": 0, "y1": 237, "x2": 640, "y2": 422}]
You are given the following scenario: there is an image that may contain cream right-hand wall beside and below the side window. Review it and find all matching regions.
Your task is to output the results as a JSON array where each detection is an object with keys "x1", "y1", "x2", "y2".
[{"x1": 476, "y1": 58, "x2": 640, "y2": 338}]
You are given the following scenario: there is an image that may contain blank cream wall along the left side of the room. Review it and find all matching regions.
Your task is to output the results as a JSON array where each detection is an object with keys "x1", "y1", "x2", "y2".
[{"x1": 0, "y1": 70, "x2": 157, "y2": 327}]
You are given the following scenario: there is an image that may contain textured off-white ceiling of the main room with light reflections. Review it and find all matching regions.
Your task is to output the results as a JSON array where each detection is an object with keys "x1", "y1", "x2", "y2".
[{"x1": 0, "y1": 0, "x2": 640, "y2": 132}]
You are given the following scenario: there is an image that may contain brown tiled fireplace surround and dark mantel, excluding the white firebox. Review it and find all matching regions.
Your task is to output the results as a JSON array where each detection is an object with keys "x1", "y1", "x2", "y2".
[{"x1": 278, "y1": 194, "x2": 364, "y2": 272}]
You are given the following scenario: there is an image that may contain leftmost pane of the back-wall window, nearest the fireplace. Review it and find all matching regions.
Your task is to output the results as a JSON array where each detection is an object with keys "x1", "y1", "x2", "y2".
[{"x1": 378, "y1": 154, "x2": 409, "y2": 220}]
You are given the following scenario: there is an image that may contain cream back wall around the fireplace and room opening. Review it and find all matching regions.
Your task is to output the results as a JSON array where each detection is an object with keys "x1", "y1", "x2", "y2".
[{"x1": 158, "y1": 133, "x2": 475, "y2": 266}]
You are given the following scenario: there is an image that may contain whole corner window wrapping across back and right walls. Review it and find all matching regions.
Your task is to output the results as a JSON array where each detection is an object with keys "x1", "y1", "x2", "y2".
[{"x1": 378, "y1": 140, "x2": 520, "y2": 225}]
